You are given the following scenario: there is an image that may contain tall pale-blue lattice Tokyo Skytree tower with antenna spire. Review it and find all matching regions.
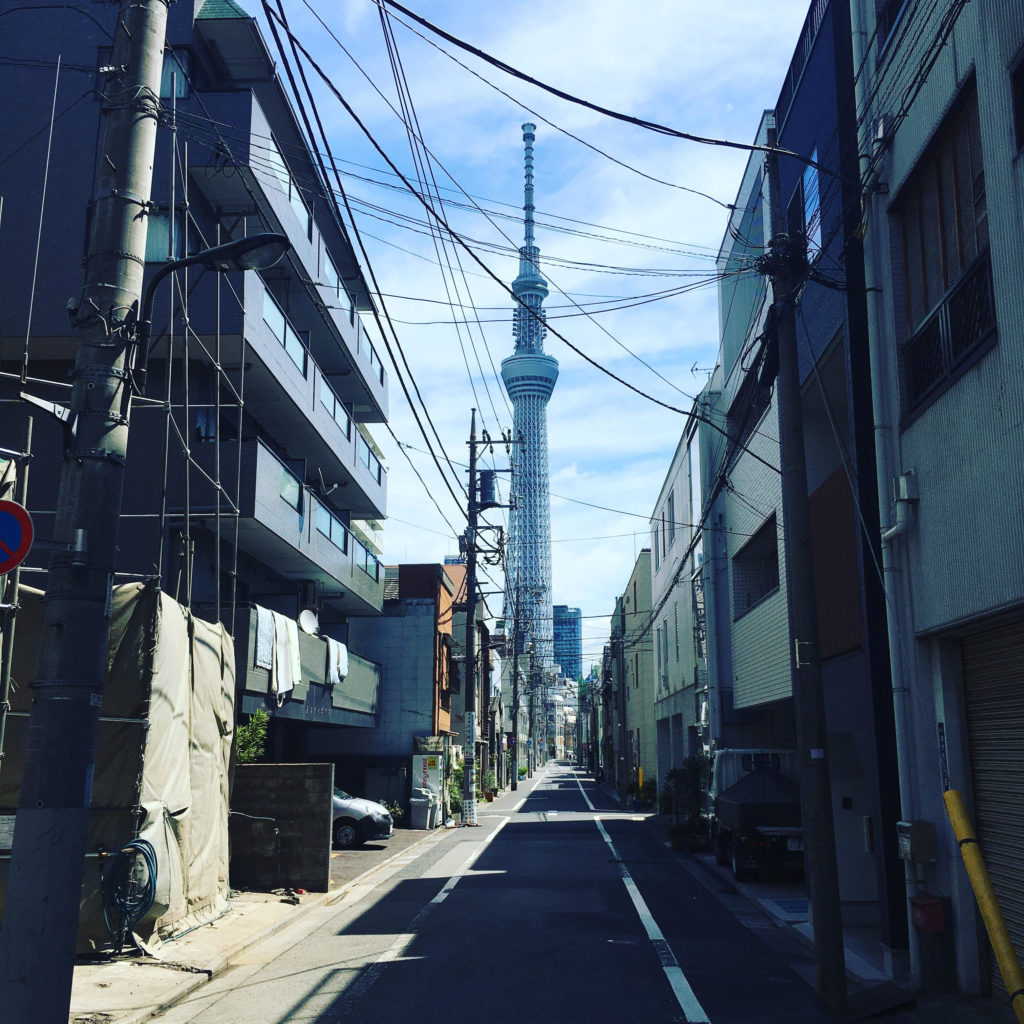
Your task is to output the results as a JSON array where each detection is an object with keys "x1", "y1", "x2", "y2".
[{"x1": 502, "y1": 124, "x2": 558, "y2": 668}]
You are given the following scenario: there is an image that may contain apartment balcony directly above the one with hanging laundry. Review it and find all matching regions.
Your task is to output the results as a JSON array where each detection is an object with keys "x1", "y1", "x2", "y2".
[{"x1": 190, "y1": 439, "x2": 384, "y2": 614}]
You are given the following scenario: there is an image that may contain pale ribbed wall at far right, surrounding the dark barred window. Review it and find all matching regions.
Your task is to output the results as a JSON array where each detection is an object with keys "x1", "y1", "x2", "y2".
[{"x1": 853, "y1": 0, "x2": 1024, "y2": 991}]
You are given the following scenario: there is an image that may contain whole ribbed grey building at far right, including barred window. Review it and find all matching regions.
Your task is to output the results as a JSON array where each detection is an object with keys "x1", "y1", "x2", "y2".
[{"x1": 853, "y1": 0, "x2": 1024, "y2": 993}]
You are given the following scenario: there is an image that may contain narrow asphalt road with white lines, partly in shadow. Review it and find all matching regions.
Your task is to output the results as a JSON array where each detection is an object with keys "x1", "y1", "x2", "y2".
[{"x1": 151, "y1": 764, "x2": 826, "y2": 1024}]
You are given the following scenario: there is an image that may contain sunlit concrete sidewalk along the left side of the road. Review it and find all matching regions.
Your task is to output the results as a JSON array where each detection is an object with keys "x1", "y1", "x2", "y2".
[{"x1": 69, "y1": 828, "x2": 444, "y2": 1024}]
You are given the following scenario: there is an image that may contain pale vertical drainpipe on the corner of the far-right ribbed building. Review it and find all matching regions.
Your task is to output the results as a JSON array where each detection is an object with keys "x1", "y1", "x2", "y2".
[{"x1": 850, "y1": 0, "x2": 921, "y2": 984}]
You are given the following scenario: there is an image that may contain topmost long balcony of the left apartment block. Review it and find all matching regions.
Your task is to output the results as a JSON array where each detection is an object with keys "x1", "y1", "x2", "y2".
[{"x1": 182, "y1": 91, "x2": 387, "y2": 423}]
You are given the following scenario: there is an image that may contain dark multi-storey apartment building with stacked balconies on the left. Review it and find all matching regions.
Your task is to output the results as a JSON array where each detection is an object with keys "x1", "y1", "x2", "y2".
[{"x1": 0, "y1": 0, "x2": 388, "y2": 758}]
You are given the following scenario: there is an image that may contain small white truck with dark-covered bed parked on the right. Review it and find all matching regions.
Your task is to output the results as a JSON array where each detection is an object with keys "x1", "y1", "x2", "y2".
[{"x1": 706, "y1": 749, "x2": 804, "y2": 882}]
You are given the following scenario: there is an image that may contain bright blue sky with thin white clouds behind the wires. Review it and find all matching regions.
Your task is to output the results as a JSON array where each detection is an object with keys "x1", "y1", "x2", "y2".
[{"x1": 256, "y1": 0, "x2": 808, "y2": 666}]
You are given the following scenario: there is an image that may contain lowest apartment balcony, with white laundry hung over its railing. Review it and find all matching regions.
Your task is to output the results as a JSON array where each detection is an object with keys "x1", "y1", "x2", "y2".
[{"x1": 236, "y1": 606, "x2": 381, "y2": 728}]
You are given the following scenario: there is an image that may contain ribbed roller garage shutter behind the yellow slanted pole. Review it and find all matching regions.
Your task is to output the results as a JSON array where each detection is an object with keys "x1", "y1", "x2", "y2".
[{"x1": 962, "y1": 620, "x2": 1024, "y2": 991}]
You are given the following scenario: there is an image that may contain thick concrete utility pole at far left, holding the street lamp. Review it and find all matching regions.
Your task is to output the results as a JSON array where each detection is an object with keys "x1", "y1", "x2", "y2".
[{"x1": 0, "y1": 0, "x2": 168, "y2": 1024}]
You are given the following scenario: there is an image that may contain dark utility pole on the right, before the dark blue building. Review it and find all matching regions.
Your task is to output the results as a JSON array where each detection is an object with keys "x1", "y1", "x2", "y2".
[{"x1": 763, "y1": 128, "x2": 847, "y2": 1016}]
